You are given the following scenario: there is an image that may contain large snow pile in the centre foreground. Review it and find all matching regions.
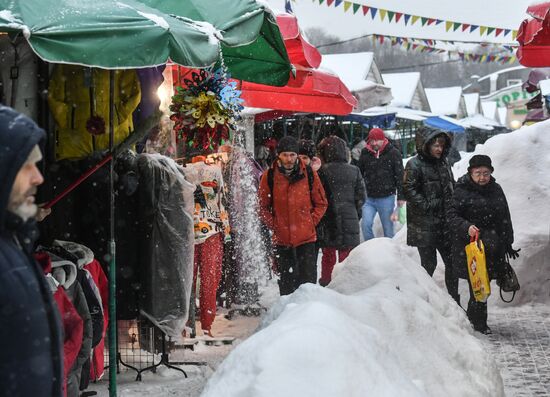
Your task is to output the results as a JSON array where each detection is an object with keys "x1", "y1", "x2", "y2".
[{"x1": 202, "y1": 239, "x2": 504, "y2": 397}]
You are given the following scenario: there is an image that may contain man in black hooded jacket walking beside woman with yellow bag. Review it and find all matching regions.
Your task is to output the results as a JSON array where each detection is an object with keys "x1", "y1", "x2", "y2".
[{"x1": 403, "y1": 127, "x2": 460, "y2": 303}]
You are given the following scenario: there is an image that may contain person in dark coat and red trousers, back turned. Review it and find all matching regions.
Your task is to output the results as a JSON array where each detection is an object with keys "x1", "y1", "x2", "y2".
[{"x1": 319, "y1": 135, "x2": 366, "y2": 286}]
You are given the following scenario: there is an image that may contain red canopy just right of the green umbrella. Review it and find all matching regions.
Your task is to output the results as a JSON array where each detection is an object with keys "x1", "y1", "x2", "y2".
[{"x1": 240, "y1": 14, "x2": 357, "y2": 115}]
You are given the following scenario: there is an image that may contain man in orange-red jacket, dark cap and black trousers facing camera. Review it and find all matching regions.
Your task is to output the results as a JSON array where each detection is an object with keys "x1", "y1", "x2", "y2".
[{"x1": 259, "y1": 136, "x2": 328, "y2": 295}]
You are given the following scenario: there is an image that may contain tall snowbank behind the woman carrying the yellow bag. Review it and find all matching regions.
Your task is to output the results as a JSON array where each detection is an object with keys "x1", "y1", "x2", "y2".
[{"x1": 453, "y1": 121, "x2": 550, "y2": 303}]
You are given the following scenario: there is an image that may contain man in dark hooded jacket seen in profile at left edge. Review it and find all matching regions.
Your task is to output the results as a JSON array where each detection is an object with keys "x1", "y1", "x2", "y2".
[{"x1": 0, "y1": 106, "x2": 63, "y2": 397}]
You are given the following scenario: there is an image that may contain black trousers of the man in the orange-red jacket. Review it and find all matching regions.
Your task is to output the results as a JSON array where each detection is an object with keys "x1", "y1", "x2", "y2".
[{"x1": 275, "y1": 243, "x2": 317, "y2": 295}]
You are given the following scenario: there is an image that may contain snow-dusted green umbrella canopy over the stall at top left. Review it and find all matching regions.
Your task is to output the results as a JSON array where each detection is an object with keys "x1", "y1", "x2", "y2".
[{"x1": 0, "y1": 0, "x2": 290, "y2": 85}]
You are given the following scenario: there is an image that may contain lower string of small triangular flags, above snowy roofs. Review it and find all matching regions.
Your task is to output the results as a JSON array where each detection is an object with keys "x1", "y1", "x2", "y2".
[{"x1": 372, "y1": 34, "x2": 516, "y2": 64}]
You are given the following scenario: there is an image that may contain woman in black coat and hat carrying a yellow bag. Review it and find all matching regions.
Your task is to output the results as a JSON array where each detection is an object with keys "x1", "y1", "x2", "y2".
[{"x1": 447, "y1": 155, "x2": 519, "y2": 334}]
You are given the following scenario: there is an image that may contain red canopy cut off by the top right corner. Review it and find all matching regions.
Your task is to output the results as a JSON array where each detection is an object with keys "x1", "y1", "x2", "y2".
[{"x1": 517, "y1": 2, "x2": 550, "y2": 67}]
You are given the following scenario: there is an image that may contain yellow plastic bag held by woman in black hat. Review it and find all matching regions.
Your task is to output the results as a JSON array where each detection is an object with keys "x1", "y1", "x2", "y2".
[{"x1": 466, "y1": 238, "x2": 491, "y2": 302}]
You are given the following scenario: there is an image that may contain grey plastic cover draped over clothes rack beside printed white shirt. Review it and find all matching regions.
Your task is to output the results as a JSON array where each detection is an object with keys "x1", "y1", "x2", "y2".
[{"x1": 138, "y1": 154, "x2": 195, "y2": 338}]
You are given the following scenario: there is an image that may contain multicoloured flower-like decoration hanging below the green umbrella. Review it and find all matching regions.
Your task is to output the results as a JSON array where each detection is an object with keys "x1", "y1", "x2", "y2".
[{"x1": 170, "y1": 67, "x2": 243, "y2": 154}]
